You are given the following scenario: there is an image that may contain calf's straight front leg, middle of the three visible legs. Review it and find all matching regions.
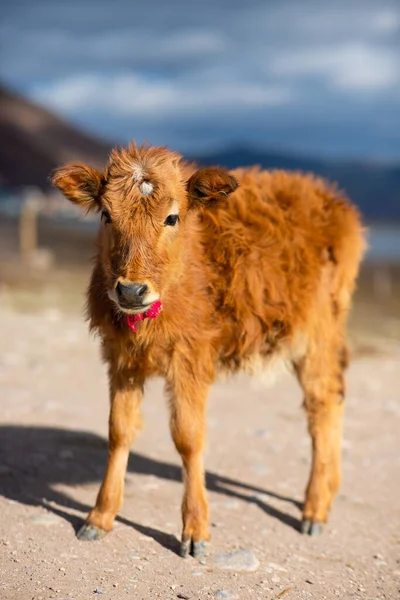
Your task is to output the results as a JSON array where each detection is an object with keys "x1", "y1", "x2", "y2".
[{"x1": 166, "y1": 381, "x2": 210, "y2": 557}]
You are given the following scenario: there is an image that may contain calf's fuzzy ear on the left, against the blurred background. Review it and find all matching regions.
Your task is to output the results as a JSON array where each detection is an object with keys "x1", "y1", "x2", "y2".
[{"x1": 51, "y1": 164, "x2": 103, "y2": 211}]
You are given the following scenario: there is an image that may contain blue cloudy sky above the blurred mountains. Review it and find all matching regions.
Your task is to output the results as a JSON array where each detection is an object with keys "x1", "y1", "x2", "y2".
[{"x1": 0, "y1": 0, "x2": 400, "y2": 162}]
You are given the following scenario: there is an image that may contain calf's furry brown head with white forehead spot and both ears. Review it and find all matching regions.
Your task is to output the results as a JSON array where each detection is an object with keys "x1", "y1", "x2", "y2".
[{"x1": 52, "y1": 144, "x2": 238, "y2": 314}]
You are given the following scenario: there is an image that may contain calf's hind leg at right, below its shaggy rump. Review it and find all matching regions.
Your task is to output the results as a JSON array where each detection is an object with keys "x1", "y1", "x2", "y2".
[{"x1": 295, "y1": 339, "x2": 347, "y2": 535}]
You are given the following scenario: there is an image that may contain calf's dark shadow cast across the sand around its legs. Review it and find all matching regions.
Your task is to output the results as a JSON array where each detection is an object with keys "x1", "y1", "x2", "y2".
[{"x1": 0, "y1": 425, "x2": 301, "y2": 552}]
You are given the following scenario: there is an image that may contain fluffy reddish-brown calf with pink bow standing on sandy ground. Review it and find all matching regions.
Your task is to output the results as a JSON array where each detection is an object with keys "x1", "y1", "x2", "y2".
[{"x1": 53, "y1": 145, "x2": 364, "y2": 556}]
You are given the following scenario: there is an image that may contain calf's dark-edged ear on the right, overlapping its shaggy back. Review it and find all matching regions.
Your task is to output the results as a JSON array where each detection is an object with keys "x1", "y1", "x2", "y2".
[{"x1": 187, "y1": 167, "x2": 239, "y2": 208}]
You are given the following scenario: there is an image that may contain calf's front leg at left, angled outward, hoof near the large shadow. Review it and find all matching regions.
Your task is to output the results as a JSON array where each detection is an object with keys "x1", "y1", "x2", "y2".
[{"x1": 77, "y1": 374, "x2": 142, "y2": 541}]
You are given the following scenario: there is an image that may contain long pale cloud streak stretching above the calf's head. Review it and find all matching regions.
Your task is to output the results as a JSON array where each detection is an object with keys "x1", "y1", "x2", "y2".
[{"x1": 32, "y1": 74, "x2": 291, "y2": 119}]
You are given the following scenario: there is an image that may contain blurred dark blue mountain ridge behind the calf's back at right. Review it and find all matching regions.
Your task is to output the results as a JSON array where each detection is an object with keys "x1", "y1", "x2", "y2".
[{"x1": 194, "y1": 146, "x2": 400, "y2": 220}]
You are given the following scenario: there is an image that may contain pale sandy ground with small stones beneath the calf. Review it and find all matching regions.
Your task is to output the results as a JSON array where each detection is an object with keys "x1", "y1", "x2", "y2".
[{"x1": 0, "y1": 255, "x2": 400, "y2": 600}]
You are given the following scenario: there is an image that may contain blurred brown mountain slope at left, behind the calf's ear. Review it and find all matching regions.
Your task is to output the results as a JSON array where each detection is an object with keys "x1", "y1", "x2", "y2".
[{"x1": 0, "y1": 86, "x2": 110, "y2": 189}]
